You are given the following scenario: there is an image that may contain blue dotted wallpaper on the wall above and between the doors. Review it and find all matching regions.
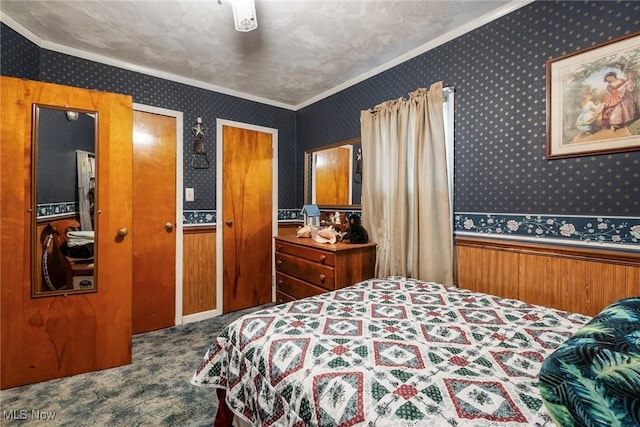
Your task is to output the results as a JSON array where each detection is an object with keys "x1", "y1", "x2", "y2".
[{"x1": 1, "y1": 24, "x2": 302, "y2": 210}]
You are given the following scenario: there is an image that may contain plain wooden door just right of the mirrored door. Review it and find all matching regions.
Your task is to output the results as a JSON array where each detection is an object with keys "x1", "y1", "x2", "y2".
[{"x1": 132, "y1": 111, "x2": 176, "y2": 334}]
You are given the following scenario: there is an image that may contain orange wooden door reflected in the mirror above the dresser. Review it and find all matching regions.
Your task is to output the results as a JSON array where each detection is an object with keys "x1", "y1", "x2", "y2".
[{"x1": 314, "y1": 147, "x2": 351, "y2": 205}]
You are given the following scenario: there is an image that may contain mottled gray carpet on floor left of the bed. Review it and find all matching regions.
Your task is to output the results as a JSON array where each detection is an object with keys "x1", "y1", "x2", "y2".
[{"x1": 0, "y1": 304, "x2": 272, "y2": 427}]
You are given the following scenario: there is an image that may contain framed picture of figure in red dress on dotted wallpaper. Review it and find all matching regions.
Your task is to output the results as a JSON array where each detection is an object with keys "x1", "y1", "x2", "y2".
[{"x1": 547, "y1": 32, "x2": 640, "y2": 159}]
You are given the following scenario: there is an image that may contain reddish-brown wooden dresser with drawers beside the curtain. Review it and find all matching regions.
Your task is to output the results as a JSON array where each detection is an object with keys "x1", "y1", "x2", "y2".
[{"x1": 275, "y1": 236, "x2": 376, "y2": 303}]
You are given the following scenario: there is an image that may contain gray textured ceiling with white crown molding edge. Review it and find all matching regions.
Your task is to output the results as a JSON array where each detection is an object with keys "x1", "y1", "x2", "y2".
[{"x1": 0, "y1": 0, "x2": 529, "y2": 109}]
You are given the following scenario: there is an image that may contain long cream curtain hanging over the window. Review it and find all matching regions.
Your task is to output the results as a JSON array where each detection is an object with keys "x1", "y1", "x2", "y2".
[{"x1": 360, "y1": 82, "x2": 453, "y2": 285}]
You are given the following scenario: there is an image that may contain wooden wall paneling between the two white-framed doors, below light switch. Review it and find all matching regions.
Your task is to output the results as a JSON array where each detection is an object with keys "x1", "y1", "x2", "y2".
[{"x1": 182, "y1": 227, "x2": 217, "y2": 315}]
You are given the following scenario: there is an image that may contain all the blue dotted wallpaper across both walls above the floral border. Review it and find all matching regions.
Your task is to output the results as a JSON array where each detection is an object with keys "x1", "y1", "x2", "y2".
[{"x1": 1, "y1": 1, "x2": 640, "y2": 227}]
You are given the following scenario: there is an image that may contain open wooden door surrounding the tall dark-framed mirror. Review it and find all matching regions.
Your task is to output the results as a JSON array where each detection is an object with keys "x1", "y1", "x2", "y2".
[{"x1": 0, "y1": 77, "x2": 132, "y2": 389}]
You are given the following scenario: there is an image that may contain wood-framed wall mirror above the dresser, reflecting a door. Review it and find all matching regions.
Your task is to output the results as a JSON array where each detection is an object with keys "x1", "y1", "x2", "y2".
[{"x1": 304, "y1": 138, "x2": 363, "y2": 209}]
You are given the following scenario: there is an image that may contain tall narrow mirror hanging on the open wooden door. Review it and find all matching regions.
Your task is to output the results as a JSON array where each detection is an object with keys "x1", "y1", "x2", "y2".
[{"x1": 31, "y1": 105, "x2": 98, "y2": 296}]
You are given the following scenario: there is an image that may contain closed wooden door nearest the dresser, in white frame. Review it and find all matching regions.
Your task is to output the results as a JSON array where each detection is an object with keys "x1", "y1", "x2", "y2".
[{"x1": 218, "y1": 126, "x2": 273, "y2": 313}]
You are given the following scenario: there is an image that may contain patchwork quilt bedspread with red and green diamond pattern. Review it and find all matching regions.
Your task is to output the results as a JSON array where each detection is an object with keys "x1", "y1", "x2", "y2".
[{"x1": 192, "y1": 277, "x2": 589, "y2": 427}]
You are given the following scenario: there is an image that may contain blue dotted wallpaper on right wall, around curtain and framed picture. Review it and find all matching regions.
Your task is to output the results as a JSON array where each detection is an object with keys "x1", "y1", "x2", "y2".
[{"x1": 297, "y1": 1, "x2": 640, "y2": 216}]
